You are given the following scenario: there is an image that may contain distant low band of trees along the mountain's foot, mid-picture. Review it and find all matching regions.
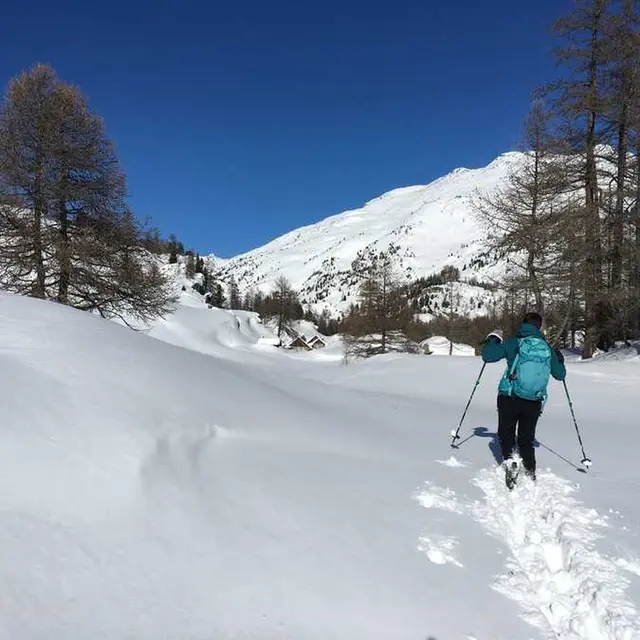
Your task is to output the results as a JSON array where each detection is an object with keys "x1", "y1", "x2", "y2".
[{"x1": 169, "y1": 247, "x2": 500, "y2": 357}]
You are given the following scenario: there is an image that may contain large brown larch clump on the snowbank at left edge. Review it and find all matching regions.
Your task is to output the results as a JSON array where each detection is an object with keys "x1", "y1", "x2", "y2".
[{"x1": 0, "y1": 65, "x2": 172, "y2": 320}]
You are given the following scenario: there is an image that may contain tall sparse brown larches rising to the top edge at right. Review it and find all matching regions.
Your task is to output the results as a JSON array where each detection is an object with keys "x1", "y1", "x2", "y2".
[{"x1": 475, "y1": 0, "x2": 640, "y2": 358}]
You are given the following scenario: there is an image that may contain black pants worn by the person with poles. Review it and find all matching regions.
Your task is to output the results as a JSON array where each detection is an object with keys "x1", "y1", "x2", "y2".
[{"x1": 498, "y1": 395, "x2": 542, "y2": 473}]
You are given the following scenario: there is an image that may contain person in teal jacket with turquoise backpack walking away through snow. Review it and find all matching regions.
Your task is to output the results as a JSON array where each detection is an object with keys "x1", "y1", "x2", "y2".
[{"x1": 482, "y1": 312, "x2": 567, "y2": 489}]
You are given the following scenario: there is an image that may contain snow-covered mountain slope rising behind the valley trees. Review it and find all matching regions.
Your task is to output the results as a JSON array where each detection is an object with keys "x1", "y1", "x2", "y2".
[{"x1": 216, "y1": 152, "x2": 523, "y2": 314}]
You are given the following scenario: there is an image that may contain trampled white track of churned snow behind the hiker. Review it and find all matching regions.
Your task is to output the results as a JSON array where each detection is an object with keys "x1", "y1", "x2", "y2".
[{"x1": 417, "y1": 469, "x2": 640, "y2": 640}]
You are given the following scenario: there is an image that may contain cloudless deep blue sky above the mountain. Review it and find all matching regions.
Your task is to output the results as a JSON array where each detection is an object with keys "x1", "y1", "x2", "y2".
[{"x1": 0, "y1": 0, "x2": 570, "y2": 257}]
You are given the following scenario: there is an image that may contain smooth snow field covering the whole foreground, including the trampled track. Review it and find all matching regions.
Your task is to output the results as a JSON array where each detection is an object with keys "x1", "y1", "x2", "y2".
[{"x1": 0, "y1": 292, "x2": 640, "y2": 640}]
